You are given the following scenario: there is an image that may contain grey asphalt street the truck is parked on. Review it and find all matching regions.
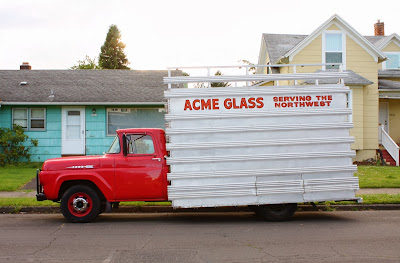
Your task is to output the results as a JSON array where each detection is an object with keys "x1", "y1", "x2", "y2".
[{"x1": 0, "y1": 210, "x2": 400, "y2": 263}]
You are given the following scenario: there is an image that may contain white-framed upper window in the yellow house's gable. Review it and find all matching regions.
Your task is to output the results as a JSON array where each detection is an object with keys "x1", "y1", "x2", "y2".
[{"x1": 324, "y1": 33, "x2": 343, "y2": 69}]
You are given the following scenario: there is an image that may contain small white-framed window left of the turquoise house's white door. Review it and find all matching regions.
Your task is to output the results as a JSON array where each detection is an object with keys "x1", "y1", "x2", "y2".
[{"x1": 12, "y1": 108, "x2": 46, "y2": 131}]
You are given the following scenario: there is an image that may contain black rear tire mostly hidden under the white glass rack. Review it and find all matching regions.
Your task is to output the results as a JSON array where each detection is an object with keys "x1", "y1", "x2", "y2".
[{"x1": 253, "y1": 204, "x2": 297, "y2": 221}]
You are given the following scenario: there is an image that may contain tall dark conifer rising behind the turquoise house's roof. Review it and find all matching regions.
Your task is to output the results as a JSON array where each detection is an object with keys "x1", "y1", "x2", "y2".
[{"x1": 99, "y1": 25, "x2": 129, "y2": 69}]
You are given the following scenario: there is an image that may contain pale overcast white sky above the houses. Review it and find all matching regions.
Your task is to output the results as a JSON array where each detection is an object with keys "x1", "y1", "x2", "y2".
[{"x1": 0, "y1": 0, "x2": 400, "y2": 70}]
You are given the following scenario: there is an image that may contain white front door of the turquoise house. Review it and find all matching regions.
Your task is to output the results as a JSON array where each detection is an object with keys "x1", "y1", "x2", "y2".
[{"x1": 61, "y1": 107, "x2": 85, "y2": 155}]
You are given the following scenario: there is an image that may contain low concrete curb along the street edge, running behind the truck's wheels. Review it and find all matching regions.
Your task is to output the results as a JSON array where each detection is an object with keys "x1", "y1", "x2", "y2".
[{"x1": 0, "y1": 204, "x2": 400, "y2": 214}]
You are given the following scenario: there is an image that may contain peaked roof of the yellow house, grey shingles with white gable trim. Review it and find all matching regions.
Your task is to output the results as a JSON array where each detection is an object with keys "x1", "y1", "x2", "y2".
[{"x1": 262, "y1": 15, "x2": 386, "y2": 64}]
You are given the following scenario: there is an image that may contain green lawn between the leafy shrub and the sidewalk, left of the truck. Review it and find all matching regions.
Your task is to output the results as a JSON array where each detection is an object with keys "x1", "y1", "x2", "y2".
[{"x1": 0, "y1": 163, "x2": 42, "y2": 191}]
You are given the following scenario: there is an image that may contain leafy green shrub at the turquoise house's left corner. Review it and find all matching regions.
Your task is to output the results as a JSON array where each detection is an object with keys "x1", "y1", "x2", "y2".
[{"x1": 0, "y1": 124, "x2": 38, "y2": 166}]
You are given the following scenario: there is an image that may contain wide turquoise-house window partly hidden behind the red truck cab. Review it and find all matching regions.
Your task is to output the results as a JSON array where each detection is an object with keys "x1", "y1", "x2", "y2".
[{"x1": 107, "y1": 108, "x2": 165, "y2": 135}]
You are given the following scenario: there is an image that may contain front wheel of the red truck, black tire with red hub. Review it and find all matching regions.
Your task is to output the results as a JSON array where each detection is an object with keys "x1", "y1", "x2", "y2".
[{"x1": 61, "y1": 185, "x2": 101, "y2": 223}]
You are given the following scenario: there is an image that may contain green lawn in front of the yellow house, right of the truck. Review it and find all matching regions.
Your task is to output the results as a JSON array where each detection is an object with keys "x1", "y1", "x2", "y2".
[{"x1": 355, "y1": 165, "x2": 400, "y2": 188}]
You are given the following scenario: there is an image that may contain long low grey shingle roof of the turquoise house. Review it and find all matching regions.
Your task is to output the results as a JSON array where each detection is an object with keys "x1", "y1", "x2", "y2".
[{"x1": 0, "y1": 70, "x2": 181, "y2": 105}]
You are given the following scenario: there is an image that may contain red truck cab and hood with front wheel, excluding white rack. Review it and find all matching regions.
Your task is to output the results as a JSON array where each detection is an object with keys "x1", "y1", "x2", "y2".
[{"x1": 37, "y1": 129, "x2": 168, "y2": 222}]
